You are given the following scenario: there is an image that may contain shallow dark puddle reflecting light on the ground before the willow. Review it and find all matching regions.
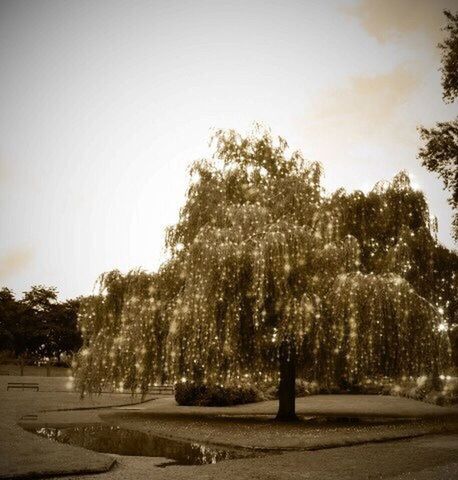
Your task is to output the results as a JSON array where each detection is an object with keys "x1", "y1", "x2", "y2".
[{"x1": 27, "y1": 424, "x2": 254, "y2": 467}]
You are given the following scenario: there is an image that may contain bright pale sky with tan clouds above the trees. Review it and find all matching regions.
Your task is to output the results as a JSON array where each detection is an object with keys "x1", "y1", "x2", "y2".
[{"x1": 0, "y1": 0, "x2": 458, "y2": 299}]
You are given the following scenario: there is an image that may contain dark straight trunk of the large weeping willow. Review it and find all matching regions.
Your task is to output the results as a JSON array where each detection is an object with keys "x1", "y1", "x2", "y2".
[{"x1": 276, "y1": 342, "x2": 298, "y2": 422}]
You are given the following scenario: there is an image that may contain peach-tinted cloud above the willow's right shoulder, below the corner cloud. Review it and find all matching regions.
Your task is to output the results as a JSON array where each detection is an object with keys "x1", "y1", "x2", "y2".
[{"x1": 306, "y1": 65, "x2": 419, "y2": 142}]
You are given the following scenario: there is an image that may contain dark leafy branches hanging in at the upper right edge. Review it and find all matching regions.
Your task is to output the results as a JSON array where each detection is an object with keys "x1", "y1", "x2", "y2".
[{"x1": 419, "y1": 10, "x2": 458, "y2": 241}]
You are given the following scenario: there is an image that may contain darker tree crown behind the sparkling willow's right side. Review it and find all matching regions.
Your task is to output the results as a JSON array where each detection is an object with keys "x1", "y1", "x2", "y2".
[{"x1": 329, "y1": 172, "x2": 458, "y2": 322}]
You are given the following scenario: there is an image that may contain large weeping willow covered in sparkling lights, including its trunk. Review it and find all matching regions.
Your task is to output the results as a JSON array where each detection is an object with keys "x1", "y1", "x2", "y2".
[{"x1": 77, "y1": 126, "x2": 449, "y2": 420}]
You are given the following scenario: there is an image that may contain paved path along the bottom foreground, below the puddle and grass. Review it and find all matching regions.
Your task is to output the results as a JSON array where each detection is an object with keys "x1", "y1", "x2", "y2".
[{"x1": 45, "y1": 435, "x2": 458, "y2": 480}]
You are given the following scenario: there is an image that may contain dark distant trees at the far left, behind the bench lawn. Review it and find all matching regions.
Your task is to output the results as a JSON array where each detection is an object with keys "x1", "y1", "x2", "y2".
[{"x1": 0, "y1": 285, "x2": 81, "y2": 362}]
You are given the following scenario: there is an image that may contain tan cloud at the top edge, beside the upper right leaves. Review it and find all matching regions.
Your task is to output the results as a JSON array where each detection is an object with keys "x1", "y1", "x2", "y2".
[{"x1": 343, "y1": 0, "x2": 458, "y2": 42}]
